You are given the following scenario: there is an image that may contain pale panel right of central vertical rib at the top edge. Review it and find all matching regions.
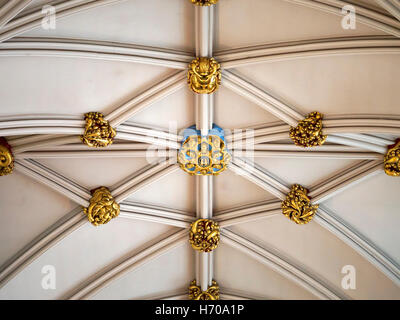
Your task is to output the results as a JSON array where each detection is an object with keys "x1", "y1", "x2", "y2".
[{"x1": 216, "y1": 0, "x2": 383, "y2": 50}]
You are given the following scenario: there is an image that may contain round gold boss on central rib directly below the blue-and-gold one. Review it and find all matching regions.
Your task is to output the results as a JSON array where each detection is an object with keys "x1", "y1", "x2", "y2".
[{"x1": 189, "y1": 219, "x2": 220, "y2": 252}]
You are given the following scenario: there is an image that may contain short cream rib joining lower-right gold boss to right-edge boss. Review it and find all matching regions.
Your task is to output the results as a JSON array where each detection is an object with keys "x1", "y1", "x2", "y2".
[{"x1": 309, "y1": 160, "x2": 383, "y2": 204}]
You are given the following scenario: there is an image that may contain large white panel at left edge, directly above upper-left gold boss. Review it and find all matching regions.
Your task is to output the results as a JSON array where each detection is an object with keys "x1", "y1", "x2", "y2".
[{"x1": 0, "y1": 57, "x2": 174, "y2": 116}]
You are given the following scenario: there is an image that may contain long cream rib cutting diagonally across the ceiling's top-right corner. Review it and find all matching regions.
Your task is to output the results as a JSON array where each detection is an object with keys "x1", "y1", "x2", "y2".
[{"x1": 285, "y1": 0, "x2": 400, "y2": 37}]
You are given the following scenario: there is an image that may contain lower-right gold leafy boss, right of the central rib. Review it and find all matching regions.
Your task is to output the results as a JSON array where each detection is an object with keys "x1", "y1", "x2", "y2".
[{"x1": 282, "y1": 184, "x2": 319, "y2": 224}]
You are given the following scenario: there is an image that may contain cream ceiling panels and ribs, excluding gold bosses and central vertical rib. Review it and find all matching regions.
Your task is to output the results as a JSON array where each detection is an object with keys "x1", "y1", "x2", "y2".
[{"x1": 0, "y1": 0, "x2": 400, "y2": 299}]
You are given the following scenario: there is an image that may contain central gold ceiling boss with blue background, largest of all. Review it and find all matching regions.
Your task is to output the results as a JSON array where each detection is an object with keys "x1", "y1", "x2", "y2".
[{"x1": 178, "y1": 135, "x2": 231, "y2": 176}]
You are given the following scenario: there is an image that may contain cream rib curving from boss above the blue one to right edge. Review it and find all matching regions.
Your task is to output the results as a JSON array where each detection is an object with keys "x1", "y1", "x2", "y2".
[{"x1": 216, "y1": 36, "x2": 400, "y2": 69}]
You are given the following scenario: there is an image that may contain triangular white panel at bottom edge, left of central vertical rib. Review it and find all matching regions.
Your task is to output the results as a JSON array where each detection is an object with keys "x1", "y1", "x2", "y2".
[{"x1": 93, "y1": 242, "x2": 195, "y2": 300}]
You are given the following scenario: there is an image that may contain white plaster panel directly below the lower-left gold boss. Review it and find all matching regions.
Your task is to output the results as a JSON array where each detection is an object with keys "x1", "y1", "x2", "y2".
[{"x1": 0, "y1": 218, "x2": 177, "y2": 299}]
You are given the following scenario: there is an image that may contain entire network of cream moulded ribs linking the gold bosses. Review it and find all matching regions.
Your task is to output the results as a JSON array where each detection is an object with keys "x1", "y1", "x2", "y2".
[{"x1": 0, "y1": 0, "x2": 400, "y2": 299}]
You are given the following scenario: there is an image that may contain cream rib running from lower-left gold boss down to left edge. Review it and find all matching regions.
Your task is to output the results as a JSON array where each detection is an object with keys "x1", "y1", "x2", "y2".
[{"x1": 0, "y1": 208, "x2": 87, "y2": 288}]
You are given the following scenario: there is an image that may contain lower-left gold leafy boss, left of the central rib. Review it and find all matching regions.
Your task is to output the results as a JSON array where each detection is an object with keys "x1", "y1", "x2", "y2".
[{"x1": 83, "y1": 187, "x2": 119, "y2": 226}]
